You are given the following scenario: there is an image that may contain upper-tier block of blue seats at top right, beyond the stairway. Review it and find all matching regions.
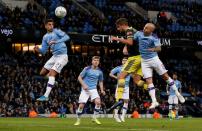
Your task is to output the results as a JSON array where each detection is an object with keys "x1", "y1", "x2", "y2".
[{"x1": 137, "y1": 0, "x2": 202, "y2": 39}]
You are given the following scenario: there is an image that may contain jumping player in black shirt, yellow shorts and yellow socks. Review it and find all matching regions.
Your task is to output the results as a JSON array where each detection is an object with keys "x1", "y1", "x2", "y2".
[{"x1": 108, "y1": 18, "x2": 147, "y2": 112}]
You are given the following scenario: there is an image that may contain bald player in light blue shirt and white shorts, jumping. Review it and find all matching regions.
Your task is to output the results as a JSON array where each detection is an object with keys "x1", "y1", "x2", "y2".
[{"x1": 134, "y1": 23, "x2": 185, "y2": 109}]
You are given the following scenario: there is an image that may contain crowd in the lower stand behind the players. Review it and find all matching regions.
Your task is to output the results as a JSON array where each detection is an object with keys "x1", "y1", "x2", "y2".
[{"x1": 0, "y1": 48, "x2": 202, "y2": 117}]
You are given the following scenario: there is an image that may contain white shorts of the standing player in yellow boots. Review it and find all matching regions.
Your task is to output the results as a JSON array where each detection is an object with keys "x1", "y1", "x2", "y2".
[{"x1": 79, "y1": 89, "x2": 100, "y2": 103}]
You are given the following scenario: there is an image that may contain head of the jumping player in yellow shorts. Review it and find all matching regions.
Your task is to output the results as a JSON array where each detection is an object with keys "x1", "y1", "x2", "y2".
[{"x1": 116, "y1": 18, "x2": 128, "y2": 32}]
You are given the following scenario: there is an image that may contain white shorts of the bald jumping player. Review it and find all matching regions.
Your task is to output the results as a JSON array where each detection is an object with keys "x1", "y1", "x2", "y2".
[{"x1": 141, "y1": 56, "x2": 168, "y2": 78}]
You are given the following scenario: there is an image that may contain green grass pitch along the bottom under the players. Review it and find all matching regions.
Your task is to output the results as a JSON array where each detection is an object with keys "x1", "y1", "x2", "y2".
[{"x1": 0, "y1": 118, "x2": 202, "y2": 131}]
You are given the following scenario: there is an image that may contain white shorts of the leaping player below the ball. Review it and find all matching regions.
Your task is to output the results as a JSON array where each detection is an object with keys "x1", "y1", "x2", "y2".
[{"x1": 44, "y1": 54, "x2": 68, "y2": 73}]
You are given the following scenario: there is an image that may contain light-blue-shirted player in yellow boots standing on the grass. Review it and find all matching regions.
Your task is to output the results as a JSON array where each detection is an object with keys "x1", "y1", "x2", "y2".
[{"x1": 74, "y1": 56, "x2": 105, "y2": 126}]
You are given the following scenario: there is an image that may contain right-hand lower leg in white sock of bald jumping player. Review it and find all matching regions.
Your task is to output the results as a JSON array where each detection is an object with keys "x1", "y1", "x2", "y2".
[{"x1": 162, "y1": 72, "x2": 185, "y2": 103}]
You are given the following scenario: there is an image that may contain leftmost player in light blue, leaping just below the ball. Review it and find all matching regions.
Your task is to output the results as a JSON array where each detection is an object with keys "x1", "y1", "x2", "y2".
[{"x1": 34, "y1": 19, "x2": 70, "y2": 101}]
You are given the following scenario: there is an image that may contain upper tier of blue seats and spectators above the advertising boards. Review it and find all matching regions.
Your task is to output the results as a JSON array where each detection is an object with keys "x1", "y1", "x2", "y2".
[{"x1": 0, "y1": 0, "x2": 202, "y2": 39}]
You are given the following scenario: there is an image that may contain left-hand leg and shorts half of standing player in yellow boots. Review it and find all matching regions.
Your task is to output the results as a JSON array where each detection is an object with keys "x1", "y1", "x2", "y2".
[{"x1": 74, "y1": 90, "x2": 90, "y2": 126}]
